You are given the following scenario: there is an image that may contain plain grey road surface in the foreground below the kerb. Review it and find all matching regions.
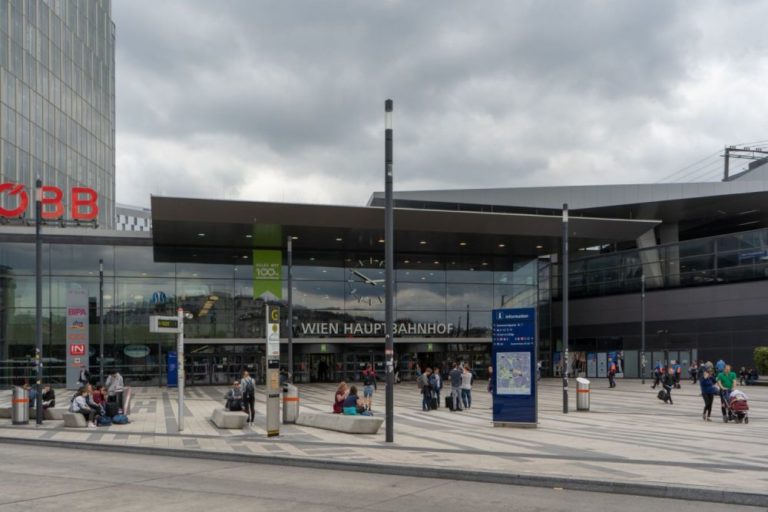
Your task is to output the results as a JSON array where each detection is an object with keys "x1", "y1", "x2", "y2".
[{"x1": 0, "y1": 445, "x2": 765, "y2": 512}]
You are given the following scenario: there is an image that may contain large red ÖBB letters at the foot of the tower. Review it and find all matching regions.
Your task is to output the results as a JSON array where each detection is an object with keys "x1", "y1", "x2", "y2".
[{"x1": 0, "y1": 183, "x2": 99, "y2": 221}]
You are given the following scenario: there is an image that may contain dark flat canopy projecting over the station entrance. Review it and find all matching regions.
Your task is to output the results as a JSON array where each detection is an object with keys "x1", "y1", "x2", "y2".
[{"x1": 152, "y1": 196, "x2": 659, "y2": 263}]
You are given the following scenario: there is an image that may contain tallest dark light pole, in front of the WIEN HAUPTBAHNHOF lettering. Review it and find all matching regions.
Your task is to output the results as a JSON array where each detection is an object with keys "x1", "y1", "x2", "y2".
[{"x1": 384, "y1": 100, "x2": 395, "y2": 443}]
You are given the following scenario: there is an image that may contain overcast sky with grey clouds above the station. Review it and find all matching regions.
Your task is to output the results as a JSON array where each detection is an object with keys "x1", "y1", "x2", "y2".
[{"x1": 113, "y1": 0, "x2": 768, "y2": 205}]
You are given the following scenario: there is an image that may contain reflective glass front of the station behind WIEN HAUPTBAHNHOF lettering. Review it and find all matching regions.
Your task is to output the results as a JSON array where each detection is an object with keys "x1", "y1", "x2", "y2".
[{"x1": 0, "y1": 237, "x2": 538, "y2": 385}]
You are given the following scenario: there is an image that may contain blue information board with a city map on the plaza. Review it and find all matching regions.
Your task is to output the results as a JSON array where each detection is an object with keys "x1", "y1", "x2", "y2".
[{"x1": 491, "y1": 308, "x2": 537, "y2": 425}]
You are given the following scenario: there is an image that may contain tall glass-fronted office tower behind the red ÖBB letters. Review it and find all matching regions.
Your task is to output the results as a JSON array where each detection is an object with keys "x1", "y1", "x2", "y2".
[{"x1": 0, "y1": 0, "x2": 115, "y2": 228}]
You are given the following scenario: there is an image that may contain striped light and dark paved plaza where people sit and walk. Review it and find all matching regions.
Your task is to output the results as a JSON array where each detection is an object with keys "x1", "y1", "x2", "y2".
[{"x1": 0, "y1": 379, "x2": 768, "y2": 505}]
